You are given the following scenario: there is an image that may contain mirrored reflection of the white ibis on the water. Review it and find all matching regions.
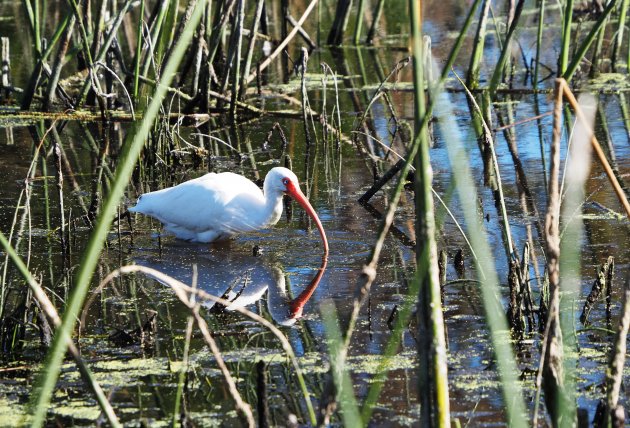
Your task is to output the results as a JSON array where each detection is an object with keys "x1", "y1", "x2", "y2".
[{"x1": 134, "y1": 246, "x2": 327, "y2": 326}]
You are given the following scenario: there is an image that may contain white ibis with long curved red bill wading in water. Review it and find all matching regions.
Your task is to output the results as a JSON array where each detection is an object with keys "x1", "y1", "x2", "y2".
[{"x1": 129, "y1": 167, "x2": 328, "y2": 255}]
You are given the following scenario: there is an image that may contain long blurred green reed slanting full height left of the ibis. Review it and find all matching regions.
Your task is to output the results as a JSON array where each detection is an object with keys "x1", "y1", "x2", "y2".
[{"x1": 30, "y1": 0, "x2": 206, "y2": 427}]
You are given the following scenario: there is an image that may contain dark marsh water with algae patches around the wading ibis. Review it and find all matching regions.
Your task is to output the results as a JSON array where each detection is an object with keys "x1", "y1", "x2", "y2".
[{"x1": 0, "y1": 1, "x2": 630, "y2": 426}]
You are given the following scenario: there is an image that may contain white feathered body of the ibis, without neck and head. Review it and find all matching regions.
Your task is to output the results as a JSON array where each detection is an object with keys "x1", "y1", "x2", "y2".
[{"x1": 134, "y1": 172, "x2": 264, "y2": 235}]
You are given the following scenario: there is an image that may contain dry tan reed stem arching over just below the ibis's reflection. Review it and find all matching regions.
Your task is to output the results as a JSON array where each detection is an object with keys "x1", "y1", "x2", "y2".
[{"x1": 97, "y1": 265, "x2": 317, "y2": 426}]
